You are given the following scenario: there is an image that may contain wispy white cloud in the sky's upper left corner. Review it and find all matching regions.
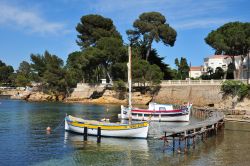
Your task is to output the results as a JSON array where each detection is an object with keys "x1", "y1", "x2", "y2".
[{"x1": 0, "y1": 3, "x2": 65, "y2": 35}]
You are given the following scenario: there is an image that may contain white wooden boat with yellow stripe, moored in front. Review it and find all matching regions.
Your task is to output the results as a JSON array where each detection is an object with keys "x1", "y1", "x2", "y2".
[{"x1": 65, "y1": 115, "x2": 149, "y2": 138}]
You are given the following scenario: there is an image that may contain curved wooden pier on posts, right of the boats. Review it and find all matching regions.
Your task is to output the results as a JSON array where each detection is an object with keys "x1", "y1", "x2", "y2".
[{"x1": 161, "y1": 110, "x2": 224, "y2": 153}]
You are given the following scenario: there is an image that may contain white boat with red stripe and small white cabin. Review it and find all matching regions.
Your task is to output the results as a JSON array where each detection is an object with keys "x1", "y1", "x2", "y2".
[{"x1": 119, "y1": 103, "x2": 192, "y2": 122}]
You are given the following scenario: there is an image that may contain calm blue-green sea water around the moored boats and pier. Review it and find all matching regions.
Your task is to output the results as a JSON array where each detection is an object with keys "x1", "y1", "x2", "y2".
[{"x1": 0, "y1": 99, "x2": 250, "y2": 166}]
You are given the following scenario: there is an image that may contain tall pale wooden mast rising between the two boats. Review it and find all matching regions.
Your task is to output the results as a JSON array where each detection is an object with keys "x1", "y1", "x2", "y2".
[{"x1": 127, "y1": 46, "x2": 132, "y2": 109}]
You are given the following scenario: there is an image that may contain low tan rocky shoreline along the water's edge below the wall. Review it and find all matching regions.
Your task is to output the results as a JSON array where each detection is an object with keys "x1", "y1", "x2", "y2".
[{"x1": 1, "y1": 90, "x2": 250, "y2": 122}]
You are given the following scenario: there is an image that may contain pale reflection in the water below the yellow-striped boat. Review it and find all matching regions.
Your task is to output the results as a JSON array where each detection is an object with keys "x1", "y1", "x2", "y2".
[{"x1": 64, "y1": 132, "x2": 149, "y2": 165}]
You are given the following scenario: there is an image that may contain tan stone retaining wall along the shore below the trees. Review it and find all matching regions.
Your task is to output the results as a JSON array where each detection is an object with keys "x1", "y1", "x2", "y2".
[{"x1": 67, "y1": 84, "x2": 222, "y2": 106}]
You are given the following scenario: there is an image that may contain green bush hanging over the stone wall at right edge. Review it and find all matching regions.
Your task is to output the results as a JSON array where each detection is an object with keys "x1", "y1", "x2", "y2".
[{"x1": 221, "y1": 81, "x2": 250, "y2": 100}]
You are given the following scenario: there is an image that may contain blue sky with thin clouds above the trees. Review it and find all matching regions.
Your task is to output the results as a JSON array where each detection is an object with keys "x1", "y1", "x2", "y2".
[{"x1": 0, "y1": 0, "x2": 250, "y2": 69}]
